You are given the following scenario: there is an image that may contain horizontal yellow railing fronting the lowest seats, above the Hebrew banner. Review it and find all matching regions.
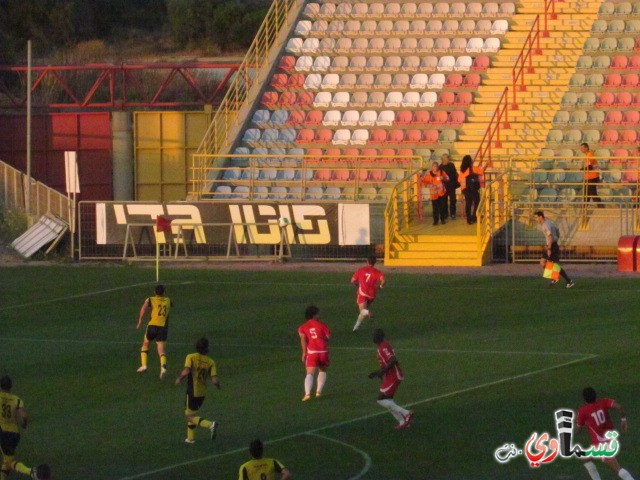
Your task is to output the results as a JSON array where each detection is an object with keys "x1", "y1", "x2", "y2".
[{"x1": 190, "y1": 154, "x2": 422, "y2": 203}]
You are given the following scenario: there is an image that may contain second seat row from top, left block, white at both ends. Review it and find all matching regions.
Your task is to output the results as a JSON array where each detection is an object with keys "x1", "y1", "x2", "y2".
[{"x1": 294, "y1": 19, "x2": 510, "y2": 37}]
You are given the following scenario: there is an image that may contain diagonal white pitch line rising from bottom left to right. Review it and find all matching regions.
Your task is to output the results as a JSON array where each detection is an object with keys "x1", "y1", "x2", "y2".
[{"x1": 120, "y1": 355, "x2": 597, "y2": 480}]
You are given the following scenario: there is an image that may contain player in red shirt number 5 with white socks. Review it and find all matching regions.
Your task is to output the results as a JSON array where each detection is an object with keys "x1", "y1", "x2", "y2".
[{"x1": 298, "y1": 305, "x2": 331, "y2": 402}]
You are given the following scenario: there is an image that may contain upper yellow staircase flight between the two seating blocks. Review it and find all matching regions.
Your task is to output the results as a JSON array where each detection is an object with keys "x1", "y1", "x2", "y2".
[{"x1": 453, "y1": 0, "x2": 601, "y2": 158}]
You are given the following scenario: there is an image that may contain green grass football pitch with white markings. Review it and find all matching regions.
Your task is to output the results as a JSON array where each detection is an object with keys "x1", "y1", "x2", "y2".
[{"x1": 0, "y1": 264, "x2": 640, "y2": 480}]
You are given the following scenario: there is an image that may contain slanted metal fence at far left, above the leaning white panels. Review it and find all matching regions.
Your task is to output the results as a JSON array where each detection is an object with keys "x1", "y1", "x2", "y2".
[{"x1": 0, "y1": 161, "x2": 71, "y2": 223}]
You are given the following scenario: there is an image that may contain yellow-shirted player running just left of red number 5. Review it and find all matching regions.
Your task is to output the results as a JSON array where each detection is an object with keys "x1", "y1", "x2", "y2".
[{"x1": 176, "y1": 337, "x2": 220, "y2": 443}]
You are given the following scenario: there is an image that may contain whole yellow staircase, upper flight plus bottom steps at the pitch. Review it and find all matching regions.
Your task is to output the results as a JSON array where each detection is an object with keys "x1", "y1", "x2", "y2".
[{"x1": 385, "y1": 0, "x2": 601, "y2": 266}]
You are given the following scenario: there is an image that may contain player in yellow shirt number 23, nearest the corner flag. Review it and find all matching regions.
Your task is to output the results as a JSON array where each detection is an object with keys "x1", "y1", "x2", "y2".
[{"x1": 136, "y1": 285, "x2": 173, "y2": 379}]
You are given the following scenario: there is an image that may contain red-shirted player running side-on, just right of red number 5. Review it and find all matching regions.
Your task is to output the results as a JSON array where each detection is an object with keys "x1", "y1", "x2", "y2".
[{"x1": 369, "y1": 328, "x2": 413, "y2": 429}]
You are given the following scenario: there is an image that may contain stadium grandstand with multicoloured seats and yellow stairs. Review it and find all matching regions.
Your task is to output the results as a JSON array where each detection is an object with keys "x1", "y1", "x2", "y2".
[{"x1": 1, "y1": 0, "x2": 640, "y2": 266}]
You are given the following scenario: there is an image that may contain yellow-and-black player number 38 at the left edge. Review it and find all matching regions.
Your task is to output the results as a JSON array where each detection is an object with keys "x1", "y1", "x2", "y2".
[{"x1": 0, "y1": 375, "x2": 51, "y2": 480}]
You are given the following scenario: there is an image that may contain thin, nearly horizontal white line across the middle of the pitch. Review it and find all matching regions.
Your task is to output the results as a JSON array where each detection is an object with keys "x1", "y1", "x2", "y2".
[{"x1": 0, "y1": 336, "x2": 597, "y2": 357}]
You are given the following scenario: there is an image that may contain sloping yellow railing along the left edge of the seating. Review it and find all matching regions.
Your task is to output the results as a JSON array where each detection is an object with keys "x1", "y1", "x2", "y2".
[{"x1": 194, "y1": 0, "x2": 303, "y2": 191}]
